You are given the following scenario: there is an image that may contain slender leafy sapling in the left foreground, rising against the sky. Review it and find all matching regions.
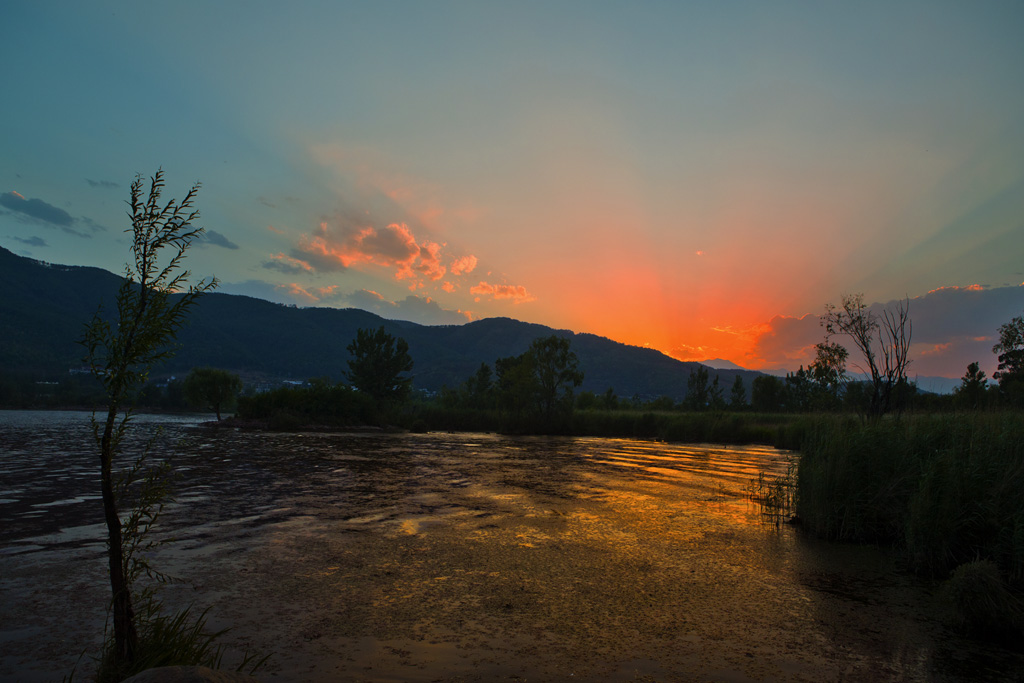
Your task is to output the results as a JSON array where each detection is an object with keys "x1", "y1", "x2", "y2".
[{"x1": 81, "y1": 170, "x2": 217, "y2": 669}]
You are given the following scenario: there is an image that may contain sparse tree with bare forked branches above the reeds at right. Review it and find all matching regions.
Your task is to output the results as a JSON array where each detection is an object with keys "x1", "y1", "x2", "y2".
[{"x1": 821, "y1": 294, "x2": 912, "y2": 416}]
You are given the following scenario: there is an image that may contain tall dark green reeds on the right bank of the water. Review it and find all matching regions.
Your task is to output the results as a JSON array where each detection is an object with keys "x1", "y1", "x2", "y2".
[{"x1": 797, "y1": 413, "x2": 1024, "y2": 582}]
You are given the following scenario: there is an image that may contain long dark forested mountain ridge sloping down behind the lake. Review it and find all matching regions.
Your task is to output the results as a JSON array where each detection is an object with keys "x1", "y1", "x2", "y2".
[{"x1": 0, "y1": 247, "x2": 760, "y2": 400}]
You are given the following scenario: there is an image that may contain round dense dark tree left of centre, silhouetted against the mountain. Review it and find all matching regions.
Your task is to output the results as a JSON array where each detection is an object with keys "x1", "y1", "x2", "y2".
[{"x1": 345, "y1": 326, "x2": 413, "y2": 405}]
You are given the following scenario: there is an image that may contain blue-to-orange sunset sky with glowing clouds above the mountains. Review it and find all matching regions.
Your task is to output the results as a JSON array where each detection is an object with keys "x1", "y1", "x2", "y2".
[{"x1": 0, "y1": 0, "x2": 1024, "y2": 377}]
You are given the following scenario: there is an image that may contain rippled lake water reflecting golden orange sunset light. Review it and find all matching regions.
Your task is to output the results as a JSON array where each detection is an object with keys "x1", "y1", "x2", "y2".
[{"x1": 0, "y1": 412, "x2": 1024, "y2": 682}]
